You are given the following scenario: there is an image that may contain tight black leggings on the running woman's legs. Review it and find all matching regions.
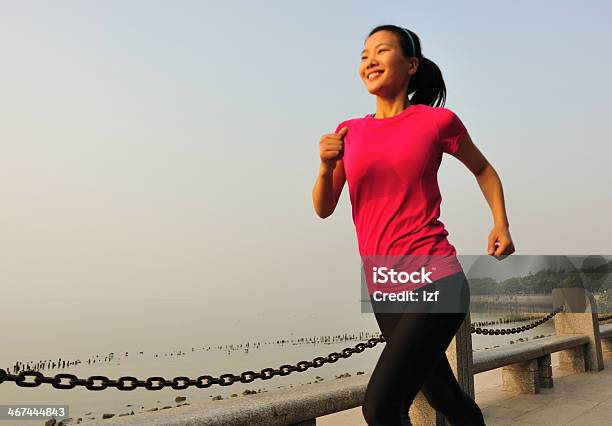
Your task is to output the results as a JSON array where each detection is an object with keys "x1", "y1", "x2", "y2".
[{"x1": 362, "y1": 272, "x2": 485, "y2": 426}]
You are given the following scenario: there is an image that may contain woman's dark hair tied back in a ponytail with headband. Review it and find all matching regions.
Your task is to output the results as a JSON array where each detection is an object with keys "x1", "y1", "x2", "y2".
[{"x1": 366, "y1": 25, "x2": 446, "y2": 106}]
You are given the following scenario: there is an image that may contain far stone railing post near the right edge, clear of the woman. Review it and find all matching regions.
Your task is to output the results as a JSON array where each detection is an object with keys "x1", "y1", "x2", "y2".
[{"x1": 552, "y1": 287, "x2": 604, "y2": 373}]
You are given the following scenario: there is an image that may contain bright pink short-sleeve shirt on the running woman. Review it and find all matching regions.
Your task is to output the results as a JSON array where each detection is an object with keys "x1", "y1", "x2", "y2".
[{"x1": 335, "y1": 104, "x2": 467, "y2": 279}]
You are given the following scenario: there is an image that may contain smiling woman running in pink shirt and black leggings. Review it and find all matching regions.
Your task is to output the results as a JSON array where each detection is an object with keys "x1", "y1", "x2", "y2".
[{"x1": 312, "y1": 25, "x2": 515, "y2": 426}]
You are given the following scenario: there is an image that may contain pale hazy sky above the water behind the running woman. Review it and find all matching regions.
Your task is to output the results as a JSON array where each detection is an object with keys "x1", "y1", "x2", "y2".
[{"x1": 0, "y1": 0, "x2": 612, "y2": 326}]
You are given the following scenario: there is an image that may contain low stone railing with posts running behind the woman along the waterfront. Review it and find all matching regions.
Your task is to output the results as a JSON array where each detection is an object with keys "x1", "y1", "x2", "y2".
[{"x1": 87, "y1": 289, "x2": 612, "y2": 426}]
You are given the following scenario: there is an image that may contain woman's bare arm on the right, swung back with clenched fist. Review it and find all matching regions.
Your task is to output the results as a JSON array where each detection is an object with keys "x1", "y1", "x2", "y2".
[{"x1": 451, "y1": 133, "x2": 515, "y2": 257}]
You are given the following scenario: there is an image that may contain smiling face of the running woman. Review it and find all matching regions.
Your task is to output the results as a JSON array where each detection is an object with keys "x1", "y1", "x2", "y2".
[{"x1": 359, "y1": 31, "x2": 418, "y2": 97}]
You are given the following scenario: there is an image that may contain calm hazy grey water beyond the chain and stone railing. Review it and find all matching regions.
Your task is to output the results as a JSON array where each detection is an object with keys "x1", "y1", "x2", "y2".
[{"x1": 0, "y1": 301, "x2": 554, "y2": 426}]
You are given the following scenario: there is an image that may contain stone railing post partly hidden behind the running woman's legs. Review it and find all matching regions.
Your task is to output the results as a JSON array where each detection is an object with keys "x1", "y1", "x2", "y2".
[{"x1": 409, "y1": 312, "x2": 475, "y2": 426}]
